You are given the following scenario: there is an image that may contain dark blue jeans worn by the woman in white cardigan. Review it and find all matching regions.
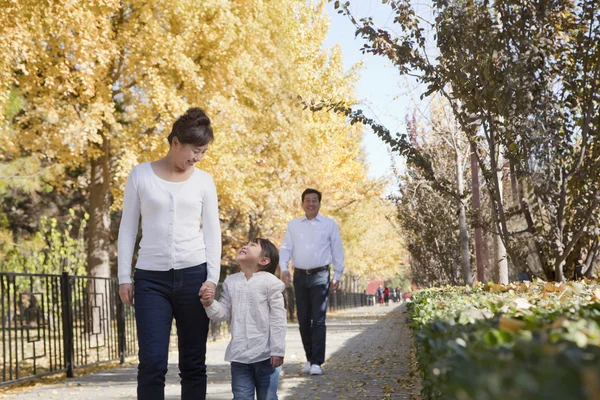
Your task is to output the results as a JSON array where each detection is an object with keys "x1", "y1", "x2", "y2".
[{"x1": 134, "y1": 263, "x2": 209, "y2": 400}]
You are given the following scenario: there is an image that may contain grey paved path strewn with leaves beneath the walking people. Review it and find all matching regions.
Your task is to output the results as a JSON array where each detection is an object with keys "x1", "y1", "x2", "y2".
[{"x1": 0, "y1": 306, "x2": 419, "y2": 400}]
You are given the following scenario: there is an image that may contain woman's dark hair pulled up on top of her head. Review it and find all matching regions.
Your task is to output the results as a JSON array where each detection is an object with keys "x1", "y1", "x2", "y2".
[{"x1": 167, "y1": 107, "x2": 214, "y2": 146}]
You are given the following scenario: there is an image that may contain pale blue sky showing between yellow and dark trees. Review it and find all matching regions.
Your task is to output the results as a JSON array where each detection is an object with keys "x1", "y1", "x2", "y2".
[{"x1": 324, "y1": 0, "x2": 422, "y2": 178}]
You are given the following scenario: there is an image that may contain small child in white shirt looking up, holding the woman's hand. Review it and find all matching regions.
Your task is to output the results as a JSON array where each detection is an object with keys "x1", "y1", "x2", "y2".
[{"x1": 200, "y1": 239, "x2": 287, "y2": 400}]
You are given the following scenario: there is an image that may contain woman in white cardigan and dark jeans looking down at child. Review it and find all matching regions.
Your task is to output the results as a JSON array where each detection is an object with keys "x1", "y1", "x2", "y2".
[{"x1": 118, "y1": 108, "x2": 221, "y2": 400}]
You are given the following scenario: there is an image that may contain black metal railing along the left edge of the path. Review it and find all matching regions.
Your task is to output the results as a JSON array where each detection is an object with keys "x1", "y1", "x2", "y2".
[{"x1": 0, "y1": 272, "x2": 372, "y2": 386}]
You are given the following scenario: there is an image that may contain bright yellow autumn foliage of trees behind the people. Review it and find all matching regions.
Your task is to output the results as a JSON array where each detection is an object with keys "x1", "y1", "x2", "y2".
[{"x1": 0, "y1": 0, "x2": 402, "y2": 277}]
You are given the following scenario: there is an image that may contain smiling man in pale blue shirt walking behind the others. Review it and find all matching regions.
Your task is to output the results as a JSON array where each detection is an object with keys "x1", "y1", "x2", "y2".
[{"x1": 279, "y1": 189, "x2": 344, "y2": 375}]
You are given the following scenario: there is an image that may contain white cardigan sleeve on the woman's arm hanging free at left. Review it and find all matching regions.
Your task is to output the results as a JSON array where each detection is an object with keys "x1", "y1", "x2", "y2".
[{"x1": 117, "y1": 168, "x2": 141, "y2": 284}]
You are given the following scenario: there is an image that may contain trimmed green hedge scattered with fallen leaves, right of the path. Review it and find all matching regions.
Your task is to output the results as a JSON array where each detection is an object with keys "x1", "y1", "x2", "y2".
[{"x1": 408, "y1": 281, "x2": 600, "y2": 400}]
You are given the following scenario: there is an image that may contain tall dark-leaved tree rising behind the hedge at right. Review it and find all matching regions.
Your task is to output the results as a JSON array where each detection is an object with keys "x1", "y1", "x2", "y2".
[{"x1": 332, "y1": 0, "x2": 600, "y2": 280}]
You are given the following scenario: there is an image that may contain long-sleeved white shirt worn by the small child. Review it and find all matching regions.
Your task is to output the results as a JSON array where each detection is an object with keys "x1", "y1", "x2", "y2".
[{"x1": 206, "y1": 271, "x2": 287, "y2": 364}]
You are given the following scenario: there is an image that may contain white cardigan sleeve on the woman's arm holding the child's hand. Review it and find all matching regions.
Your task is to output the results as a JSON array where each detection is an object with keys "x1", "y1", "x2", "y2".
[{"x1": 202, "y1": 175, "x2": 221, "y2": 285}]
